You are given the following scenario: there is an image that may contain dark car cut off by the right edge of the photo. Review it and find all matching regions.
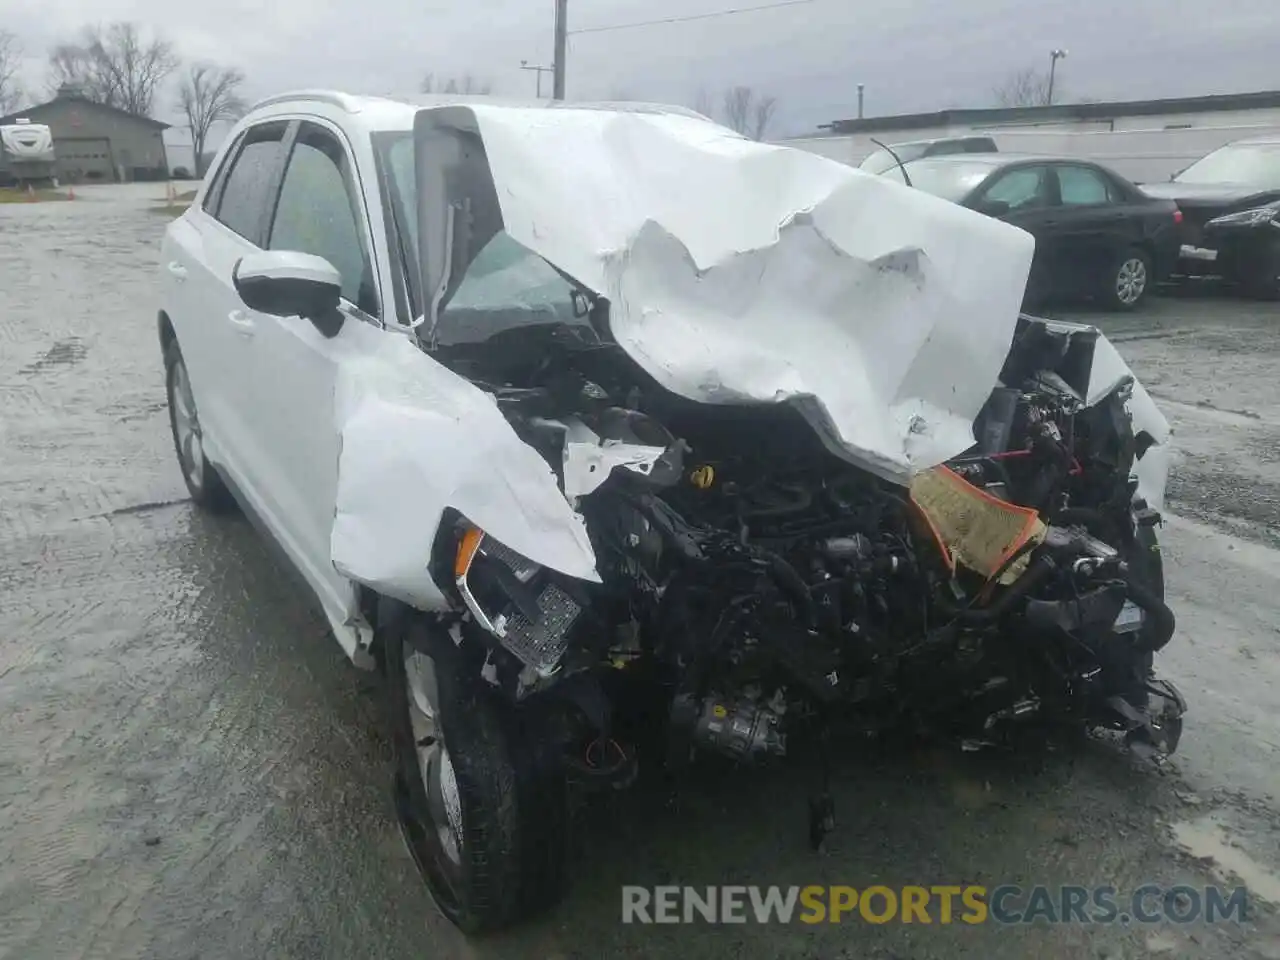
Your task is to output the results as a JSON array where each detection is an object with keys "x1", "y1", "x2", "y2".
[{"x1": 1142, "y1": 136, "x2": 1280, "y2": 298}]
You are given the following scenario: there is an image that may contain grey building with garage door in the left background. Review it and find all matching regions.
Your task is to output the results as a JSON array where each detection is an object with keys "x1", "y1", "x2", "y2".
[{"x1": 0, "y1": 87, "x2": 169, "y2": 183}]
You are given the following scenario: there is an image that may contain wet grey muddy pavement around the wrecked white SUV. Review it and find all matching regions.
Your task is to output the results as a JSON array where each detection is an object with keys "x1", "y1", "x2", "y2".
[{"x1": 0, "y1": 197, "x2": 1280, "y2": 960}]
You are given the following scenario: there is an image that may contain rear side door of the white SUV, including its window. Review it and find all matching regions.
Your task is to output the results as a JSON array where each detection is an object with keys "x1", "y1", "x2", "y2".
[{"x1": 161, "y1": 120, "x2": 289, "y2": 503}]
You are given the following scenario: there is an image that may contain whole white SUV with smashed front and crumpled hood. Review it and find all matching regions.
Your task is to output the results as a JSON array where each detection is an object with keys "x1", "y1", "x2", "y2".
[{"x1": 159, "y1": 91, "x2": 1183, "y2": 931}]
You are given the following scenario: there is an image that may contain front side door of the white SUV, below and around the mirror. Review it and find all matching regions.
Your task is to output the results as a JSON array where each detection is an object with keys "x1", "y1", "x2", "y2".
[{"x1": 229, "y1": 119, "x2": 389, "y2": 653}]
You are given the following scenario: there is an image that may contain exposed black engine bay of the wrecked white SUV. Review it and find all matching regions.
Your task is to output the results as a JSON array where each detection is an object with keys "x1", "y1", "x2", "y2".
[{"x1": 433, "y1": 309, "x2": 1185, "y2": 842}]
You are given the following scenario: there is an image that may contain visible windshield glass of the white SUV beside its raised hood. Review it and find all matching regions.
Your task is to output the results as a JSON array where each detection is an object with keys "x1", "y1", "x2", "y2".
[{"x1": 381, "y1": 133, "x2": 591, "y2": 347}]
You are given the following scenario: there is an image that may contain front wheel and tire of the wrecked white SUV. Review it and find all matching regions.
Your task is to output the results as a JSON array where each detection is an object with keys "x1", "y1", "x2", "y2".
[{"x1": 383, "y1": 614, "x2": 568, "y2": 934}]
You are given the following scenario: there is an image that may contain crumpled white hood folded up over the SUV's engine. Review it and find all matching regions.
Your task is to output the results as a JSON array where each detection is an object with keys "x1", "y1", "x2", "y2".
[{"x1": 415, "y1": 105, "x2": 1034, "y2": 484}]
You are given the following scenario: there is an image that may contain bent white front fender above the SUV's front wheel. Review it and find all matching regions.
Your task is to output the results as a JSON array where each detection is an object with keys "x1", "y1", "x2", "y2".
[{"x1": 330, "y1": 337, "x2": 599, "y2": 609}]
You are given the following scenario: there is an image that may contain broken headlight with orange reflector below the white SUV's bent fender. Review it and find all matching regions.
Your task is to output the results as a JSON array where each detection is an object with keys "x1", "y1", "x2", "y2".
[{"x1": 453, "y1": 526, "x2": 582, "y2": 678}]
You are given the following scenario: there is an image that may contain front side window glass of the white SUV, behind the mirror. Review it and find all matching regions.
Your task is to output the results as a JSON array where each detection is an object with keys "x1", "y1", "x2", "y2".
[{"x1": 268, "y1": 123, "x2": 379, "y2": 316}]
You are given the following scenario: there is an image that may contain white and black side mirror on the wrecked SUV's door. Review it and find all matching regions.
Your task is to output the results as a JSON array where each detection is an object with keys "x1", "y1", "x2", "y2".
[{"x1": 232, "y1": 250, "x2": 343, "y2": 337}]
